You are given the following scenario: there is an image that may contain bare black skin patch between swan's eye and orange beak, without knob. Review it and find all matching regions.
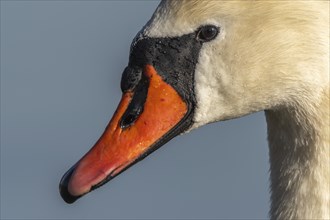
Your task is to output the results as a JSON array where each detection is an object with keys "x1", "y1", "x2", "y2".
[{"x1": 129, "y1": 33, "x2": 202, "y2": 102}]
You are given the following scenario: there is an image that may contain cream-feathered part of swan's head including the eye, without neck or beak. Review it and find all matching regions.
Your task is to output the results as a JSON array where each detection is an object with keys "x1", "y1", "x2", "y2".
[{"x1": 144, "y1": 0, "x2": 329, "y2": 128}]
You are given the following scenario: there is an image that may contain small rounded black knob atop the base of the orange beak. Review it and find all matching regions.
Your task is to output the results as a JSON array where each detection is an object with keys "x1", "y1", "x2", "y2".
[{"x1": 120, "y1": 66, "x2": 142, "y2": 92}]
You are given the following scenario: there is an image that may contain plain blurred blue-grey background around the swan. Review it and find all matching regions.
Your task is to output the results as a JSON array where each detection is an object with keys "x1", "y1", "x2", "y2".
[{"x1": 0, "y1": 0, "x2": 269, "y2": 219}]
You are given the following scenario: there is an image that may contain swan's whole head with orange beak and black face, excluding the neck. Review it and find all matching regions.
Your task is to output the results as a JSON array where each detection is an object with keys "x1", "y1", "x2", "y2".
[{"x1": 60, "y1": 0, "x2": 329, "y2": 203}]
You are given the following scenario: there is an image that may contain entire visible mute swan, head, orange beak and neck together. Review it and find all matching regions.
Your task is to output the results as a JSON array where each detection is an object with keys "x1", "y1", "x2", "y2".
[{"x1": 60, "y1": 0, "x2": 330, "y2": 219}]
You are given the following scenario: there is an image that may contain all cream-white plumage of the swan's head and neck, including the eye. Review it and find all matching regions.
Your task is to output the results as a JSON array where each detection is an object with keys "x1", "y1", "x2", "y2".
[{"x1": 142, "y1": 0, "x2": 330, "y2": 219}]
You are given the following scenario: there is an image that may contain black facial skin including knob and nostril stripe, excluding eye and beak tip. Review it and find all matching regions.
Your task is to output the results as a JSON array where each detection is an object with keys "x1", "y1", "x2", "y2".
[{"x1": 121, "y1": 31, "x2": 202, "y2": 133}]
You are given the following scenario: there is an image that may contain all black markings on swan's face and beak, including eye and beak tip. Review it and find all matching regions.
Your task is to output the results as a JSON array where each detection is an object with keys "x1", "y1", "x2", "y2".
[{"x1": 60, "y1": 25, "x2": 219, "y2": 203}]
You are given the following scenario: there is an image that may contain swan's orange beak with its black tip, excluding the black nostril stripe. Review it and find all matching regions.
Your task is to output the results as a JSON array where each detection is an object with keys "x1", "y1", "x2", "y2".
[{"x1": 60, "y1": 65, "x2": 189, "y2": 203}]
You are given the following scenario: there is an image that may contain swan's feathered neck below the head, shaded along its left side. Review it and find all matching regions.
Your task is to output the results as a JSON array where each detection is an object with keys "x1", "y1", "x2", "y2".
[{"x1": 266, "y1": 96, "x2": 330, "y2": 219}]
